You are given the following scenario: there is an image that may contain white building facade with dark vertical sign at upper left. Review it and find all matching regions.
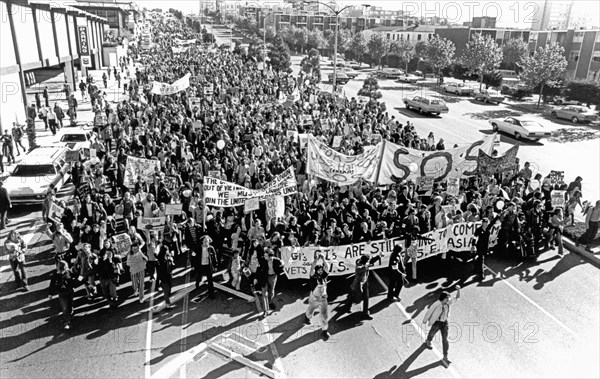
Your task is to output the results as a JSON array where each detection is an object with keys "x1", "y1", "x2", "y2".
[{"x1": 0, "y1": 0, "x2": 107, "y2": 129}]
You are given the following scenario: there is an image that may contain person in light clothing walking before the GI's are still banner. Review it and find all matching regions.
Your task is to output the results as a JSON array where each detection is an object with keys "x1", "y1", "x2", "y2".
[{"x1": 304, "y1": 253, "x2": 330, "y2": 341}]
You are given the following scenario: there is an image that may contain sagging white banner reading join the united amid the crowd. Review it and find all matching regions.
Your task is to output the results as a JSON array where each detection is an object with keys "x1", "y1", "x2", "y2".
[{"x1": 203, "y1": 167, "x2": 298, "y2": 207}]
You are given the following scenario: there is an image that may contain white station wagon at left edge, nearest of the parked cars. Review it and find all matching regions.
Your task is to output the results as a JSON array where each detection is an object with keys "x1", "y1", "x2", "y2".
[{"x1": 4, "y1": 145, "x2": 71, "y2": 204}]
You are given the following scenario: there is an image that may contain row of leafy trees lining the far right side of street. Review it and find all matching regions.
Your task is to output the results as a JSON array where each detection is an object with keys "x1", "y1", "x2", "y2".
[{"x1": 227, "y1": 13, "x2": 598, "y2": 105}]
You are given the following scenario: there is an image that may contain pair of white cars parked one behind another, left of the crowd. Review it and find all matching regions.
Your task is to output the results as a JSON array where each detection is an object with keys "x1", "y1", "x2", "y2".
[{"x1": 3, "y1": 128, "x2": 96, "y2": 205}]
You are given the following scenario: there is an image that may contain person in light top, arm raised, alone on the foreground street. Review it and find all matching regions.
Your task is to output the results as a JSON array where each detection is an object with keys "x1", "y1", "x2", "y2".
[{"x1": 423, "y1": 285, "x2": 460, "y2": 366}]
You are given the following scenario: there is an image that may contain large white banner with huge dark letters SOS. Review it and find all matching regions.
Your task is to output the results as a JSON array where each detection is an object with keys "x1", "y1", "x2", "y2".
[{"x1": 376, "y1": 134, "x2": 496, "y2": 185}]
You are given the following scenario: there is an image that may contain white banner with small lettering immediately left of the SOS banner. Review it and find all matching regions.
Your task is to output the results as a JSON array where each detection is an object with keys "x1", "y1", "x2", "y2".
[{"x1": 306, "y1": 134, "x2": 383, "y2": 185}]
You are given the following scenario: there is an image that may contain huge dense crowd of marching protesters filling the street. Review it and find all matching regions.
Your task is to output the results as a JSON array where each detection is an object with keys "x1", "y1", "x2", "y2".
[{"x1": 5, "y1": 13, "x2": 600, "y2": 336}]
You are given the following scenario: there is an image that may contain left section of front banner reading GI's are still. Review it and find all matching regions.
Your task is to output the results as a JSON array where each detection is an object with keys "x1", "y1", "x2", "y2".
[{"x1": 281, "y1": 238, "x2": 403, "y2": 279}]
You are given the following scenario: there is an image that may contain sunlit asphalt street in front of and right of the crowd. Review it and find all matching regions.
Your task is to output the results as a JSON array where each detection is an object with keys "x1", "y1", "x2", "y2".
[{"x1": 0, "y1": 29, "x2": 600, "y2": 378}]
